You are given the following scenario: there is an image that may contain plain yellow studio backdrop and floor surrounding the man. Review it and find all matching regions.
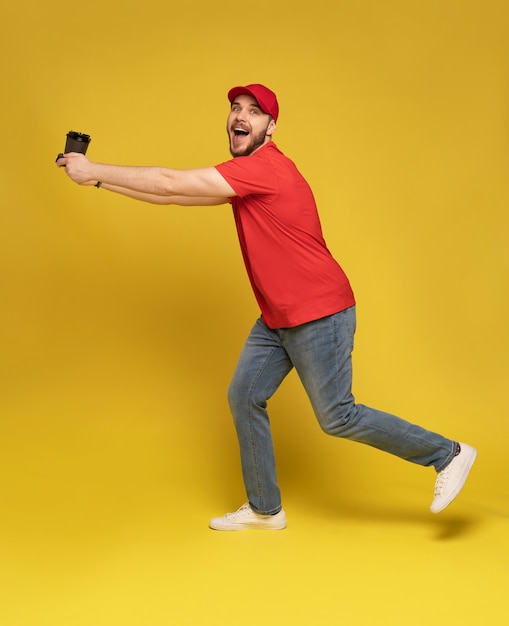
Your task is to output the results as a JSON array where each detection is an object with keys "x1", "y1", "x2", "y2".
[{"x1": 0, "y1": 0, "x2": 509, "y2": 626}]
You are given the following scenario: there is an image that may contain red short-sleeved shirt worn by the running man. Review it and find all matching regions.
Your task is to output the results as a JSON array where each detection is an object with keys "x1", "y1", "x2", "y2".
[{"x1": 216, "y1": 141, "x2": 355, "y2": 328}]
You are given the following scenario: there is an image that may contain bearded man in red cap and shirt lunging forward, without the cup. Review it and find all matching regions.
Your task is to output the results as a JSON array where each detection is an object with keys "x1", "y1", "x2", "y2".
[{"x1": 57, "y1": 84, "x2": 477, "y2": 530}]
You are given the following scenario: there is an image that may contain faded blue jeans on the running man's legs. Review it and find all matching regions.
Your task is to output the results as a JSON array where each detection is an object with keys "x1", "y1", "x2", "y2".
[{"x1": 228, "y1": 307, "x2": 456, "y2": 515}]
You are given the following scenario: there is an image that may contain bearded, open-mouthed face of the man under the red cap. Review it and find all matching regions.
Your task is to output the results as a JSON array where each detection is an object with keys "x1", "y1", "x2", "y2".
[{"x1": 226, "y1": 94, "x2": 276, "y2": 157}]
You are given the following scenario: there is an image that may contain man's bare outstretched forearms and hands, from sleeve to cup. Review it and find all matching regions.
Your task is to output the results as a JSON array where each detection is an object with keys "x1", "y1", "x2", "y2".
[{"x1": 57, "y1": 152, "x2": 236, "y2": 205}]
